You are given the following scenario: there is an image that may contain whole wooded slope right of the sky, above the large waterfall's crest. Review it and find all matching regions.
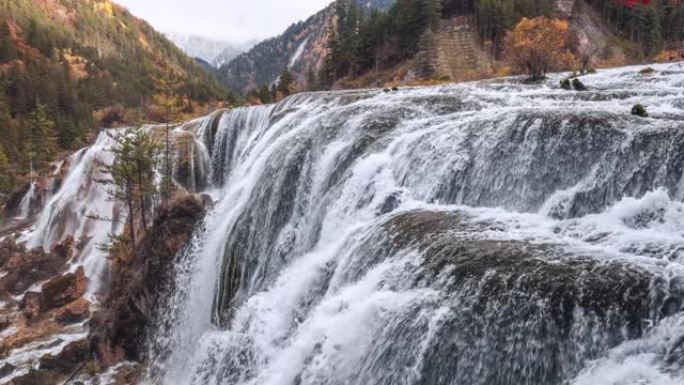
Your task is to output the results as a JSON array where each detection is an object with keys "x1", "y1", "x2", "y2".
[{"x1": 219, "y1": 0, "x2": 684, "y2": 96}]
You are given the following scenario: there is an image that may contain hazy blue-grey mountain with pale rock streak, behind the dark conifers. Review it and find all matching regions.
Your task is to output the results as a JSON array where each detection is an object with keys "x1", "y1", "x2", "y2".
[{"x1": 219, "y1": 0, "x2": 395, "y2": 93}]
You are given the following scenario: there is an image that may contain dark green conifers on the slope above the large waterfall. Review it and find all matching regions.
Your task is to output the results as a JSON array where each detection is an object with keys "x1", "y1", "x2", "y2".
[{"x1": 308, "y1": 0, "x2": 684, "y2": 89}]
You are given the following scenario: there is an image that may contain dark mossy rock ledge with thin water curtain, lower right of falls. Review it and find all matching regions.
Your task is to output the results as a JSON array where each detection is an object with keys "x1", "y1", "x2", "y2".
[{"x1": 366, "y1": 211, "x2": 682, "y2": 385}]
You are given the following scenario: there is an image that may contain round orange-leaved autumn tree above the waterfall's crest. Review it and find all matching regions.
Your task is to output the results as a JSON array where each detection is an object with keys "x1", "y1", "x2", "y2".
[{"x1": 506, "y1": 17, "x2": 573, "y2": 80}]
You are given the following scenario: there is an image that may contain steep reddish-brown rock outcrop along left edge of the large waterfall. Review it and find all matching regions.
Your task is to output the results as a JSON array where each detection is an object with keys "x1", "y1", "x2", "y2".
[{"x1": 90, "y1": 195, "x2": 205, "y2": 366}]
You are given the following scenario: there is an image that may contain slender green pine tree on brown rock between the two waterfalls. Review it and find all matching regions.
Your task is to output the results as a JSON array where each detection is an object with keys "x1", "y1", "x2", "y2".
[{"x1": 96, "y1": 130, "x2": 158, "y2": 250}]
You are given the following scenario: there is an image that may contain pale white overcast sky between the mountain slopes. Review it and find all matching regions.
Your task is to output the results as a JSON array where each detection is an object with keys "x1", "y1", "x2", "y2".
[{"x1": 114, "y1": 0, "x2": 331, "y2": 42}]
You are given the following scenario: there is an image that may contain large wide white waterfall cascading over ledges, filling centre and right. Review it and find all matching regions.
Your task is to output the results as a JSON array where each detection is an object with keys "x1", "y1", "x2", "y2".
[{"x1": 140, "y1": 64, "x2": 684, "y2": 385}]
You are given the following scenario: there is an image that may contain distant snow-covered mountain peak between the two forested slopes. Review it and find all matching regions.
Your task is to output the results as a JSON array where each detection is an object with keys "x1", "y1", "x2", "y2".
[{"x1": 168, "y1": 34, "x2": 254, "y2": 68}]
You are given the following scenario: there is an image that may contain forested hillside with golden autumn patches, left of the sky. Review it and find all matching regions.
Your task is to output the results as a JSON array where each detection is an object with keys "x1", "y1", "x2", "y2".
[{"x1": 0, "y1": 0, "x2": 227, "y2": 194}]
